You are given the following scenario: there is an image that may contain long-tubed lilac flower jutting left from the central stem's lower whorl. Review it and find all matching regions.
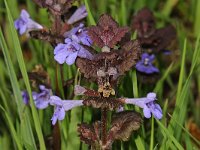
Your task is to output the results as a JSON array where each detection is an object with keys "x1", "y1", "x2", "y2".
[{"x1": 50, "y1": 96, "x2": 83, "y2": 125}]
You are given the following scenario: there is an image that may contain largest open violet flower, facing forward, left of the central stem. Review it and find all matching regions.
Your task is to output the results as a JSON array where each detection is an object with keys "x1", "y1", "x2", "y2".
[{"x1": 54, "y1": 38, "x2": 93, "y2": 65}]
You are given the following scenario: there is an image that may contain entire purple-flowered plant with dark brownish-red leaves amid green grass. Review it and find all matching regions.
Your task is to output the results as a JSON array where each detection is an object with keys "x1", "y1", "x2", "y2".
[{"x1": 12, "y1": 0, "x2": 177, "y2": 150}]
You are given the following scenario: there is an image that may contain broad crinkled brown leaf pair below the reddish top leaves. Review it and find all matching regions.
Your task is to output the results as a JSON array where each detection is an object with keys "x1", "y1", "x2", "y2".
[{"x1": 76, "y1": 40, "x2": 141, "y2": 84}]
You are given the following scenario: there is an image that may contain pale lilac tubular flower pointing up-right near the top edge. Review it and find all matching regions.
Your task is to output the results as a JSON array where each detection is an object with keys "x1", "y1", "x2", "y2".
[{"x1": 67, "y1": 5, "x2": 88, "y2": 24}]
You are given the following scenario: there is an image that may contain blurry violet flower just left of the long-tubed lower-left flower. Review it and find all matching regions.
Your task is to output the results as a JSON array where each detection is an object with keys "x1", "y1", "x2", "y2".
[{"x1": 32, "y1": 85, "x2": 51, "y2": 109}]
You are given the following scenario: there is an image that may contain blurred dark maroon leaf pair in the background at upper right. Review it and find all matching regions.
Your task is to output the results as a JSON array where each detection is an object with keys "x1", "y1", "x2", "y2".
[{"x1": 132, "y1": 8, "x2": 176, "y2": 51}]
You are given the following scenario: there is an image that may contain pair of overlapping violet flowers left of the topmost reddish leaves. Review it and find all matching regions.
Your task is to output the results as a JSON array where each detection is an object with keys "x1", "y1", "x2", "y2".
[{"x1": 54, "y1": 24, "x2": 93, "y2": 65}]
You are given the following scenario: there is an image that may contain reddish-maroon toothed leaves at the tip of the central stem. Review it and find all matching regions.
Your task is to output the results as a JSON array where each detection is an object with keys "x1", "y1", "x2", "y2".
[{"x1": 88, "y1": 14, "x2": 129, "y2": 48}]
